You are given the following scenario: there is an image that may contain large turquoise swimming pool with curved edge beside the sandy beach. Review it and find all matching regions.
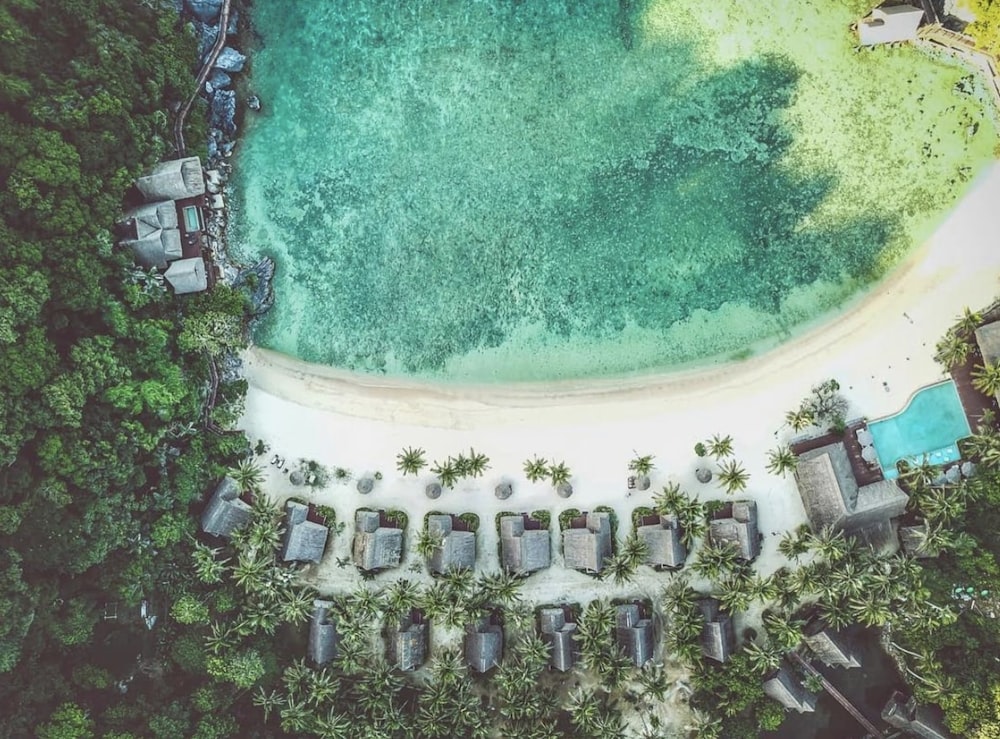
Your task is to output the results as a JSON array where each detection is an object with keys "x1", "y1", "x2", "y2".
[{"x1": 868, "y1": 380, "x2": 970, "y2": 479}]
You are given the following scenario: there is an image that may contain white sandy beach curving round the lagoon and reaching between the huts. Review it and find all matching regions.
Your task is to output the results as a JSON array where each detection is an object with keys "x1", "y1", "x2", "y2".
[{"x1": 243, "y1": 159, "x2": 1000, "y2": 632}]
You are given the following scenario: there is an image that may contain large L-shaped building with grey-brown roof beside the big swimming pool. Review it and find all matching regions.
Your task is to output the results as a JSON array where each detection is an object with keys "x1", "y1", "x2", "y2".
[{"x1": 795, "y1": 442, "x2": 908, "y2": 534}]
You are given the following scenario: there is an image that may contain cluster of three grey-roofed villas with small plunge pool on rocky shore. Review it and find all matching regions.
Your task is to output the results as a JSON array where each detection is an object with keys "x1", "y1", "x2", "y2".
[{"x1": 120, "y1": 157, "x2": 208, "y2": 295}]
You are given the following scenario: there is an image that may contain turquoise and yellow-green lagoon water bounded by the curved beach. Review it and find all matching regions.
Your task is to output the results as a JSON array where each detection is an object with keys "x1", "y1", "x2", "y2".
[{"x1": 230, "y1": 0, "x2": 996, "y2": 382}]
